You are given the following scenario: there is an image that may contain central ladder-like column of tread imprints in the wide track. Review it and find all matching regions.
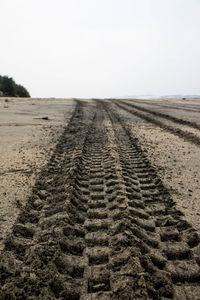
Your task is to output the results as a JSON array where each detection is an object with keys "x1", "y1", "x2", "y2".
[{"x1": 80, "y1": 105, "x2": 112, "y2": 300}]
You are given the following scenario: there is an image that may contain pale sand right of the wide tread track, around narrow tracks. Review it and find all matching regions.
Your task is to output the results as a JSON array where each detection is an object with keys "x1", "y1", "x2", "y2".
[{"x1": 111, "y1": 99, "x2": 200, "y2": 231}]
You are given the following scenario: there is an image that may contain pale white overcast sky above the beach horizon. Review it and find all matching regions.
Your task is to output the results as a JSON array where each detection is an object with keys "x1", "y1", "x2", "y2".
[{"x1": 0, "y1": 0, "x2": 200, "y2": 97}]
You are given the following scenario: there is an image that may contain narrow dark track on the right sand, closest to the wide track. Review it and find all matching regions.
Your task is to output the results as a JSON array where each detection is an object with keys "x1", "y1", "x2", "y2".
[{"x1": 113, "y1": 101, "x2": 200, "y2": 146}]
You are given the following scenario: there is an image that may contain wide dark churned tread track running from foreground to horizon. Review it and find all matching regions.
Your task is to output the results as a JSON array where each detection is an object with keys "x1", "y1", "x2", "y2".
[{"x1": 0, "y1": 100, "x2": 200, "y2": 300}]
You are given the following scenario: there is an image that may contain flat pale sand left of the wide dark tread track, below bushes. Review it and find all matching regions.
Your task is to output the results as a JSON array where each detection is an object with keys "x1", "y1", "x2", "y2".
[{"x1": 0, "y1": 98, "x2": 75, "y2": 249}]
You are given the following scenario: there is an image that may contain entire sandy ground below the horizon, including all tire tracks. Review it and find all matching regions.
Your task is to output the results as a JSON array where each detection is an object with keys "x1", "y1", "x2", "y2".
[{"x1": 0, "y1": 98, "x2": 200, "y2": 300}]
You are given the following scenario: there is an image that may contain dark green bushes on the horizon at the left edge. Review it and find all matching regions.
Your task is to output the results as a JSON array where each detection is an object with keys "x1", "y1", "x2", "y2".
[{"x1": 0, "y1": 75, "x2": 30, "y2": 97}]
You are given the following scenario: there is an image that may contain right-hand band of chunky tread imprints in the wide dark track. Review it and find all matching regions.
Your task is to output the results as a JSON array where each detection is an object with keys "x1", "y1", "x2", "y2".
[{"x1": 102, "y1": 104, "x2": 200, "y2": 299}]
